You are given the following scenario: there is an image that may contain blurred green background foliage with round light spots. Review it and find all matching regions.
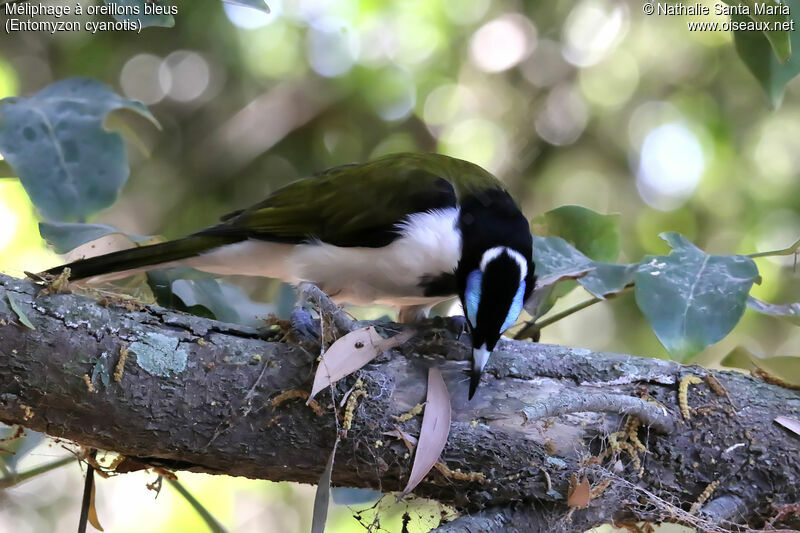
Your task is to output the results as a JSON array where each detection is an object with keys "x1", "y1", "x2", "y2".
[{"x1": 0, "y1": 0, "x2": 800, "y2": 531}]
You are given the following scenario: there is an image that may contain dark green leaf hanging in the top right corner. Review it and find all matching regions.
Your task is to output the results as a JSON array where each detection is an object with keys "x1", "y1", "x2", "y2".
[{"x1": 731, "y1": 0, "x2": 800, "y2": 107}]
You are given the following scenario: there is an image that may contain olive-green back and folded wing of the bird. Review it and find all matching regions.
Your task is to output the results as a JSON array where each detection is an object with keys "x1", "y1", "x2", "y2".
[{"x1": 201, "y1": 154, "x2": 499, "y2": 247}]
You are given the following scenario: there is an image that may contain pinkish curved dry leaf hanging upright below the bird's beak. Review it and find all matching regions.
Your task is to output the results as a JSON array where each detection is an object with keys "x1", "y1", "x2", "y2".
[{"x1": 402, "y1": 367, "x2": 451, "y2": 496}]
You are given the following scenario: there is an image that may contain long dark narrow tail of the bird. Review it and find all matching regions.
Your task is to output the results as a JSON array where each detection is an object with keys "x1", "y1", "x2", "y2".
[{"x1": 43, "y1": 235, "x2": 240, "y2": 280}]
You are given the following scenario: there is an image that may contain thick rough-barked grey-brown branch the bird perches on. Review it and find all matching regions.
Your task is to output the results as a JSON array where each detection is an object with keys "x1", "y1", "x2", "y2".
[{"x1": 0, "y1": 276, "x2": 800, "y2": 531}]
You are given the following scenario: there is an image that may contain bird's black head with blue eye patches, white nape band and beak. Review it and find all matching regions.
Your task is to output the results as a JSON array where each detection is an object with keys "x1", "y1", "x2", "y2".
[{"x1": 456, "y1": 190, "x2": 535, "y2": 399}]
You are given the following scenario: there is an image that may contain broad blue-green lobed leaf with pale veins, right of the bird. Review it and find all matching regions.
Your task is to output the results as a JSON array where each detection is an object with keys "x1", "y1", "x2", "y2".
[{"x1": 634, "y1": 233, "x2": 758, "y2": 361}]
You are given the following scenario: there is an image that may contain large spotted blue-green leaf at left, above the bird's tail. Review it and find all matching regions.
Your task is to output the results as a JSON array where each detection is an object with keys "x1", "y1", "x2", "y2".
[{"x1": 0, "y1": 78, "x2": 156, "y2": 221}]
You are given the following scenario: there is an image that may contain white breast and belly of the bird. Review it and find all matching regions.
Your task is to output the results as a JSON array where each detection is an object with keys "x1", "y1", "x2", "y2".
[{"x1": 191, "y1": 208, "x2": 461, "y2": 305}]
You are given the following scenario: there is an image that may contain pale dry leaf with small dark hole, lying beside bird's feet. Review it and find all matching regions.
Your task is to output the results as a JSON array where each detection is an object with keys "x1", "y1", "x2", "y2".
[{"x1": 309, "y1": 326, "x2": 414, "y2": 401}]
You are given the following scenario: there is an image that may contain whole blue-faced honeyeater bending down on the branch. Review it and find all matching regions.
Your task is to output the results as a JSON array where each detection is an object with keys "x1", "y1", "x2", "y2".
[{"x1": 46, "y1": 153, "x2": 535, "y2": 400}]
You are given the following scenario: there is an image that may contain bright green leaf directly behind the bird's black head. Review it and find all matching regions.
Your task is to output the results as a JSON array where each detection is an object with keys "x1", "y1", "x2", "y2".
[{"x1": 532, "y1": 205, "x2": 620, "y2": 263}]
